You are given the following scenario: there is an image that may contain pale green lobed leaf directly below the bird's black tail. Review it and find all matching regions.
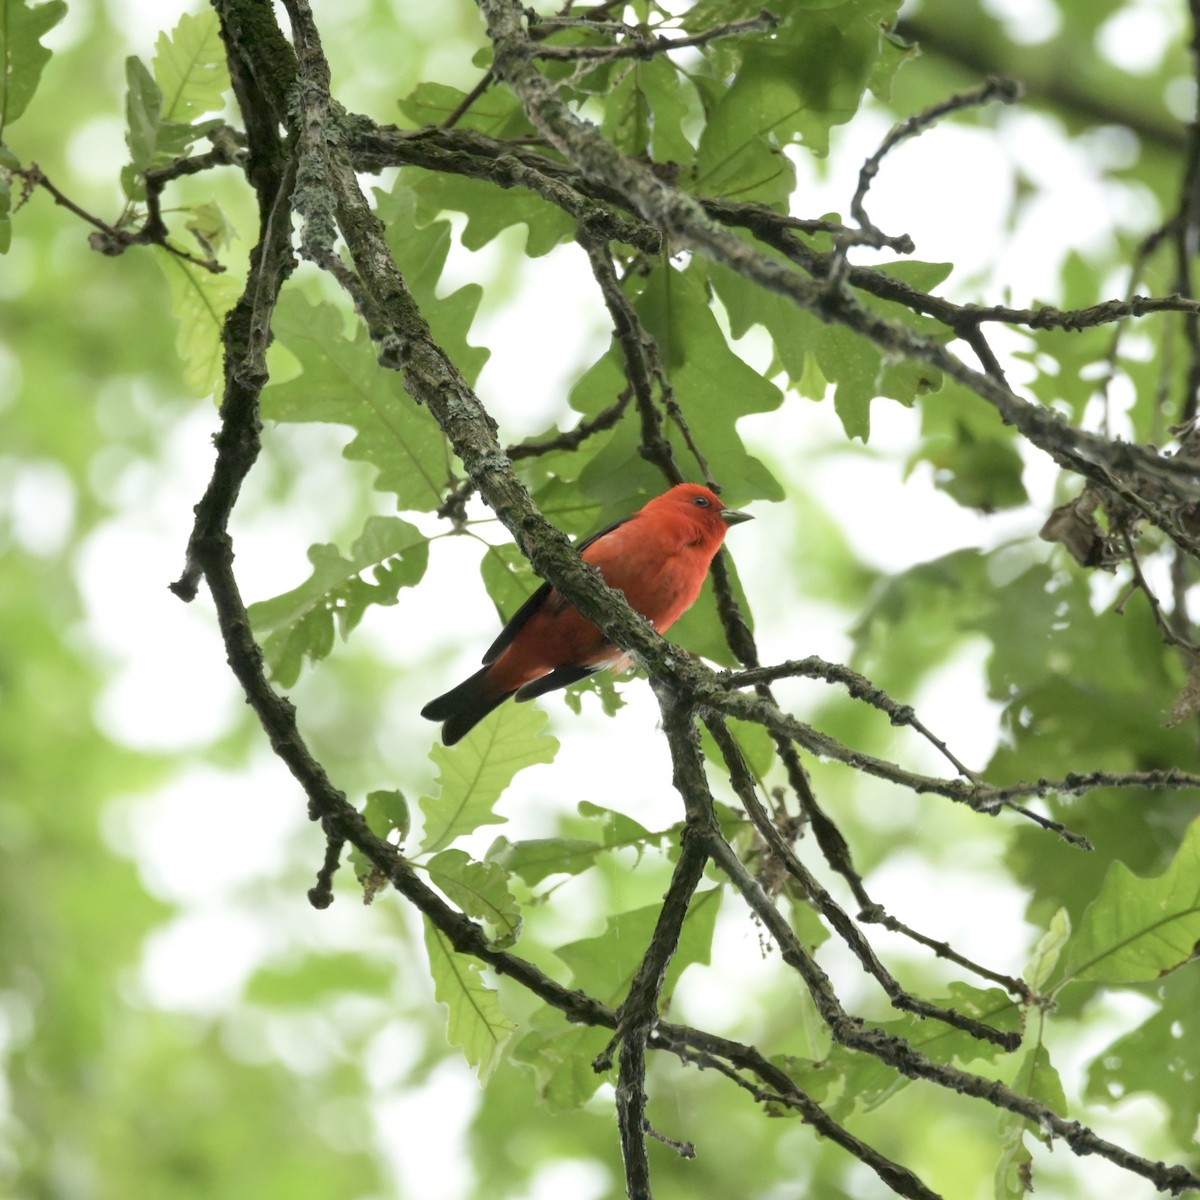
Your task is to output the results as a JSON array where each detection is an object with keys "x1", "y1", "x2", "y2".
[{"x1": 421, "y1": 704, "x2": 558, "y2": 853}]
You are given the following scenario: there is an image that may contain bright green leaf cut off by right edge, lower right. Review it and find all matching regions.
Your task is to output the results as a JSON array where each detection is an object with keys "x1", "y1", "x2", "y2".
[{"x1": 1064, "y1": 821, "x2": 1200, "y2": 984}]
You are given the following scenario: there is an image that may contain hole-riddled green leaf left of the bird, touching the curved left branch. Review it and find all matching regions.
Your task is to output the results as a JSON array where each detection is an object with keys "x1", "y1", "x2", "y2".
[{"x1": 250, "y1": 516, "x2": 430, "y2": 688}]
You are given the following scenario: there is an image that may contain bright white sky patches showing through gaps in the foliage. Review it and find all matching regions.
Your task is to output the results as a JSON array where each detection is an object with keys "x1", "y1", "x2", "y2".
[{"x1": 23, "y1": 0, "x2": 1182, "y2": 1200}]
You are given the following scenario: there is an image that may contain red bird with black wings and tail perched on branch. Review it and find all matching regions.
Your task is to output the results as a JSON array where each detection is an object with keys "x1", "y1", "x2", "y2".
[{"x1": 421, "y1": 484, "x2": 752, "y2": 746}]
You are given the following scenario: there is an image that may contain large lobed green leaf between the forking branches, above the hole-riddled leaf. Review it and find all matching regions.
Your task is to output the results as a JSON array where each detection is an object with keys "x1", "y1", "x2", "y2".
[{"x1": 263, "y1": 297, "x2": 451, "y2": 512}]
